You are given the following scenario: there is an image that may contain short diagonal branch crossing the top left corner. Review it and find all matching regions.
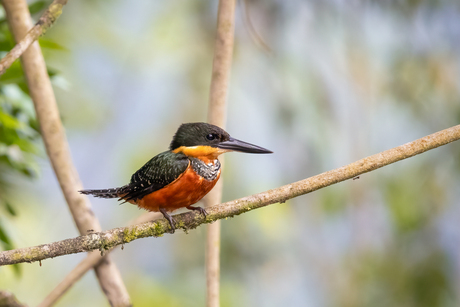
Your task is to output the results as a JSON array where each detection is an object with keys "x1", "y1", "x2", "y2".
[{"x1": 0, "y1": 0, "x2": 67, "y2": 76}]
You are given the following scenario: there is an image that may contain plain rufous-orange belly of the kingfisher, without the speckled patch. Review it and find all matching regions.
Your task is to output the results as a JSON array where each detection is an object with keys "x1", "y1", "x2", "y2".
[{"x1": 135, "y1": 165, "x2": 220, "y2": 212}]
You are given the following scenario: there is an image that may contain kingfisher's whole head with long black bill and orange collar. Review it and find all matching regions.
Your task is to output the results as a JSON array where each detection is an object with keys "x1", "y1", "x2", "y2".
[{"x1": 169, "y1": 123, "x2": 272, "y2": 159}]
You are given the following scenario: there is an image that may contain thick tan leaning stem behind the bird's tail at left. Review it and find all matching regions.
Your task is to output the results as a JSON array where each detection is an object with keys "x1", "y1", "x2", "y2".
[{"x1": 2, "y1": 0, "x2": 131, "y2": 306}]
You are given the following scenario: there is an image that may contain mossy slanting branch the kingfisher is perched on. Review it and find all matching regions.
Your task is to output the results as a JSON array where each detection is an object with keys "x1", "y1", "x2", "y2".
[{"x1": 0, "y1": 125, "x2": 460, "y2": 266}]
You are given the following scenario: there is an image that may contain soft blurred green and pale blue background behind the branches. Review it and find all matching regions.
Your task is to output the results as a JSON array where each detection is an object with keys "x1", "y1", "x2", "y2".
[{"x1": 0, "y1": 0, "x2": 460, "y2": 307}]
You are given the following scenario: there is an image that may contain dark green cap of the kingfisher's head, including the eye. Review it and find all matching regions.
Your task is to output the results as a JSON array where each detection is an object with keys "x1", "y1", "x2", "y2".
[{"x1": 169, "y1": 123, "x2": 230, "y2": 150}]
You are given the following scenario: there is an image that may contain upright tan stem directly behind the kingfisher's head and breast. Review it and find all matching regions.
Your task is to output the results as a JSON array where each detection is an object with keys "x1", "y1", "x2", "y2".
[{"x1": 205, "y1": 0, "x2": 236, "y2": 307}]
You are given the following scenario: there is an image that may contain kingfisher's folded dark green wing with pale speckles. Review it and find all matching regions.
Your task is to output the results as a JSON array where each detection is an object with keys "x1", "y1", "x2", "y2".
[{"x1": 120, "y1": 151, "x2": 190, "y2": 201}]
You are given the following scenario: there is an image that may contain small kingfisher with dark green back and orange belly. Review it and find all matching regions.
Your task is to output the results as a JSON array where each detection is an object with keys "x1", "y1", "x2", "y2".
[{"x1": 79, "y1": 122, "x2": 273, "y2": 233}]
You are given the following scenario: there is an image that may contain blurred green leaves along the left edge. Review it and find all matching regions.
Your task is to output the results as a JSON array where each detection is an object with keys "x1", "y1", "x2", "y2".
[{"x1": 0, "y1": 1, "x2": 63, "y2": 260}]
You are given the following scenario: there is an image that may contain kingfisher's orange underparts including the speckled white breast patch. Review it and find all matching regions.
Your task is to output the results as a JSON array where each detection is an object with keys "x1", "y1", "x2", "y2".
[{"x1": 136, "y1": 158, "x2": 221, "y2": 212}]
